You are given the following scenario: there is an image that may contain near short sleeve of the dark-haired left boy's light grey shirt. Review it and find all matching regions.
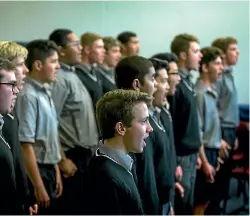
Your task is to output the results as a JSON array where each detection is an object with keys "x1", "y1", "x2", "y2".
[{"x1": 16, "y1": 94, "x2": 38, "y2": 143}]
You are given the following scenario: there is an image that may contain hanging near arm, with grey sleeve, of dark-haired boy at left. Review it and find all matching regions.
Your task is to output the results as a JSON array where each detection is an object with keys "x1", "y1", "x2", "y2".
[{"x1": 16, "y1": 94, "x2": 49, "y2": 207}]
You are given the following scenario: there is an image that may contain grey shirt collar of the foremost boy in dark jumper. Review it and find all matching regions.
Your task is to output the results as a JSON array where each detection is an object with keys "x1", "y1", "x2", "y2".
[{"x1": 99, "y1": 141, "x2": 133, "y2": 172}]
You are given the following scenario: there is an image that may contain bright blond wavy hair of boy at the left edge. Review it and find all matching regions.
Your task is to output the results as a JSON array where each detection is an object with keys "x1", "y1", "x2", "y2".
[{"x1": 0, "y1": 41, "x2": 28, "y2": 61}]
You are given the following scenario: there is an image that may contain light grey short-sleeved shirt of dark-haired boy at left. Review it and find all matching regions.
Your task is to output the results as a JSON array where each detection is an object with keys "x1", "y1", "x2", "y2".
[{"x1": 16, "y1": 77, "x2": 61, "y2": 164}]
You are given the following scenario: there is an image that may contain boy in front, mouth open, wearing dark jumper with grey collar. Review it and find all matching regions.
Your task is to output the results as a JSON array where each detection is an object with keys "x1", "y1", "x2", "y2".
[{"x1": 82, "y1": 90, "x2": 152, "y2": 215}]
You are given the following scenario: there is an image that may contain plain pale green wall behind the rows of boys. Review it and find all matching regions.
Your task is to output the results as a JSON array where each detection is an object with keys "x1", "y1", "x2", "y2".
[{"x1": 0, "y1": 1, "x2": 249, "y2": 103}]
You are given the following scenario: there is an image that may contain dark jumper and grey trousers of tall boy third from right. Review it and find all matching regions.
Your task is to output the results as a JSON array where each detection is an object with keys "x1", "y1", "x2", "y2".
[{"x1": 168, "y1": 70, "x2": 201, "y2": 214}]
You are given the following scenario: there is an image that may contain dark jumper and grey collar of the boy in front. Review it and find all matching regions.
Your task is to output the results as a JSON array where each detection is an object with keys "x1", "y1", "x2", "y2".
[{"x1": 81, "y1": 143, "x2": 143, "y2": 215}]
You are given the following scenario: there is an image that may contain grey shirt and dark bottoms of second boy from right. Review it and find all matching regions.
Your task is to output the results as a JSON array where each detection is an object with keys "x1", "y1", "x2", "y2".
[{"x1": 195, "y1": 80, "x2": 221, "y2": 205}]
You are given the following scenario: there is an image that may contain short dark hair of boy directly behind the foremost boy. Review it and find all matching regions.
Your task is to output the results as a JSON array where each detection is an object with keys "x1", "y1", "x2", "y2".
[{"x1": 115, "y1": 56, "x2": 153, "y2": 89}]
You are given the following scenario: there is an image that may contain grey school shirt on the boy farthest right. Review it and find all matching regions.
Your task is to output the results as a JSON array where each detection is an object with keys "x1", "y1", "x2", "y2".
[{"x1": 216, "y1": 68, "x2": 239, "y2": 128}]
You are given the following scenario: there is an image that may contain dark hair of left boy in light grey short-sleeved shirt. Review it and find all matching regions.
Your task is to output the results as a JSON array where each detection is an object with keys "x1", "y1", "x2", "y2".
[{"x1": 25, "y1": 40, "x2": 58, "y2": 71}]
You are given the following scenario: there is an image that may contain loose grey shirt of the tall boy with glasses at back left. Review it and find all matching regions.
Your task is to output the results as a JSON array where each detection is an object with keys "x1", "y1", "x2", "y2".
[{"x1": 51, "y1": 63, "x2": 99, "y2": 151}]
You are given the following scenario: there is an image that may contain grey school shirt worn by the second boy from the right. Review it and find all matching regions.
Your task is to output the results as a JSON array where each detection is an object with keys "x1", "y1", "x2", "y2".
[{"x1": 195, "y1": 79, "x2": 221, "y2": 148}]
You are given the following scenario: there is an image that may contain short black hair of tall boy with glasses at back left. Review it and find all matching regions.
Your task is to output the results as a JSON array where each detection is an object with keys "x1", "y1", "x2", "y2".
[{"x1": 49, "y1": 29, "x2": 73, "y2": 47}]
